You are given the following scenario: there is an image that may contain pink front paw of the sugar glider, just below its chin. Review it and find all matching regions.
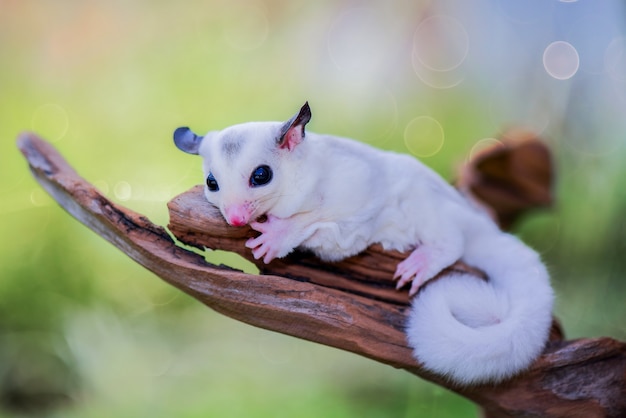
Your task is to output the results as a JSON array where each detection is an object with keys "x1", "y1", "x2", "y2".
[{"x1": 245, "y1": 215, "x2": 293, "y2": 264}]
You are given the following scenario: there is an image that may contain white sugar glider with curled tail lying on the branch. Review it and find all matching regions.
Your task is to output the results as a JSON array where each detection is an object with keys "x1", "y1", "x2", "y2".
[{"x1": 174, "y1": 103, "x2": 553, "y2": 385}]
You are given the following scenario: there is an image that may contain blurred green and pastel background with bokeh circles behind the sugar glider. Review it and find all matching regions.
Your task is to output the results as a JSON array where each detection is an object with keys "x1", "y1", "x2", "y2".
[{"x1": 0, "y1": 0, "x2": 626, "y2": 417}]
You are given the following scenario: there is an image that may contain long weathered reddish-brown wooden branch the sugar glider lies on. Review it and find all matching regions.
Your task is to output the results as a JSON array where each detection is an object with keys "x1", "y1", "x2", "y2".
[{"x1": 18, "y1": 133, "x2": 626, "y2": 418}]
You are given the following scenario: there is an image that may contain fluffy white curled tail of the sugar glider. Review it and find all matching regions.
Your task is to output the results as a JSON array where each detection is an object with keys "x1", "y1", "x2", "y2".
[{"x1": 407, "y1": 229, "x2": 553, "y2": 384}]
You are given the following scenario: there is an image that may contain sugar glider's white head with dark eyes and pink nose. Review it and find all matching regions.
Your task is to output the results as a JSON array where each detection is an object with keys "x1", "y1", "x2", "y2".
[{"x1": 174, "y1": 102, "x2": 311, "y2": 226}]
